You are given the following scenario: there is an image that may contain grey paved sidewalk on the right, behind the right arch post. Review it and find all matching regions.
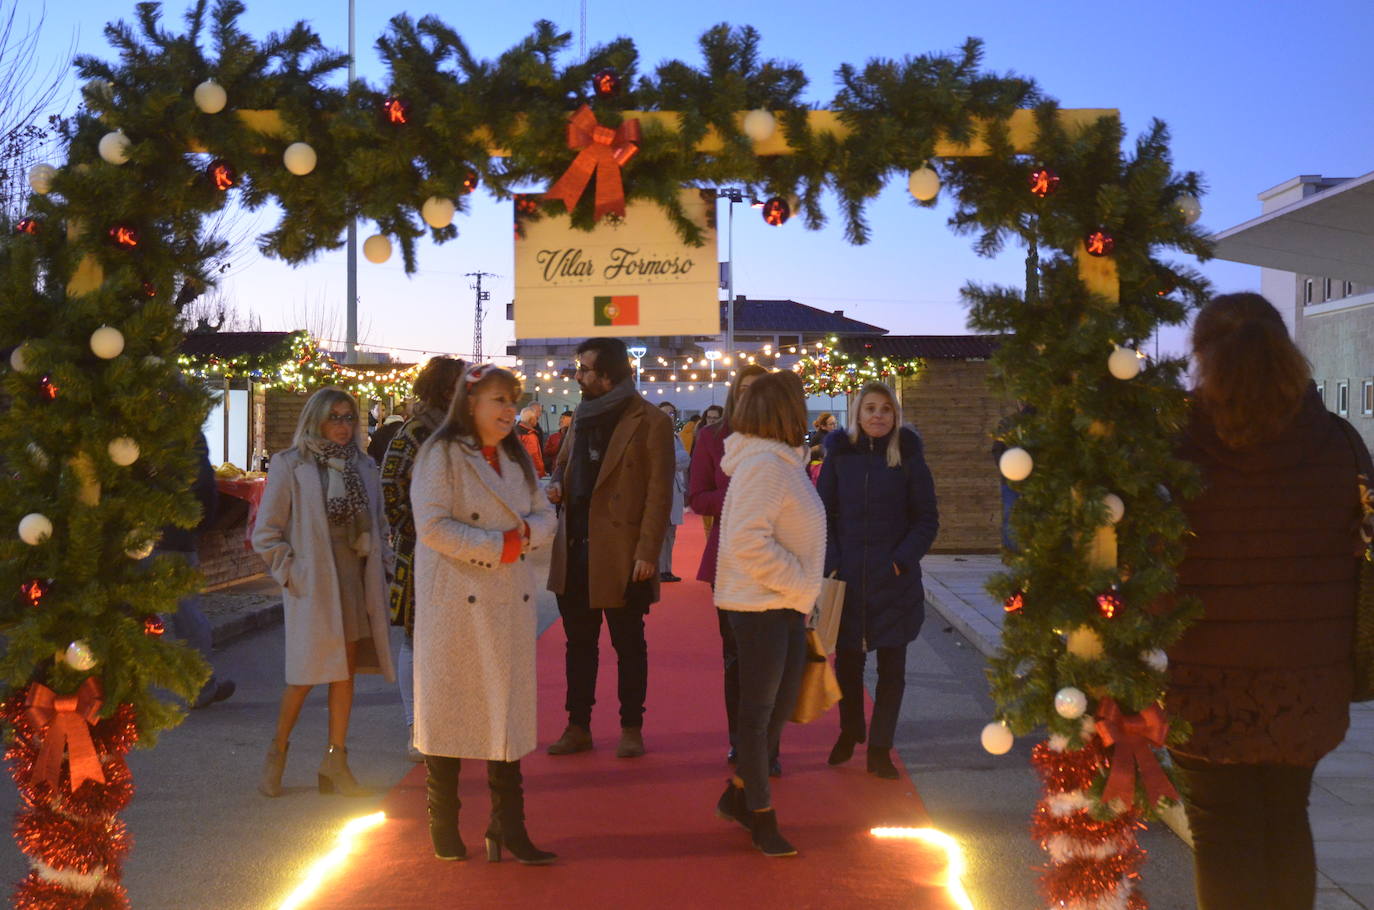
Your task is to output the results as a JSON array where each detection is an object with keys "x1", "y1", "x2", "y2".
[{"x1": 921, "y1": 555, "x2": 1374, "y2": 910}]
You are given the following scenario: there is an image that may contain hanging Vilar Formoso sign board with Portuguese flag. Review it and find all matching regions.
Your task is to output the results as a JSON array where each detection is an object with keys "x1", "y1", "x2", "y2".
[{"x1": 515, "y1": 190, "x2": 720, "y2": 338}]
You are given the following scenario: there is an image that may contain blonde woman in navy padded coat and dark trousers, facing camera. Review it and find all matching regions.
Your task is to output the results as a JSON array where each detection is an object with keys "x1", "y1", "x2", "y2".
[{"x1": 816, "y1": 382, "x2": 940, "y2": 779}]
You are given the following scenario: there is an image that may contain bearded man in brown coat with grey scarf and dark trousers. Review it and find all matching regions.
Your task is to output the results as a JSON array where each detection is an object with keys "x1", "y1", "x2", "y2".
[{"x1": 548, "y1": 338, "x2": 673, "y2": 757}]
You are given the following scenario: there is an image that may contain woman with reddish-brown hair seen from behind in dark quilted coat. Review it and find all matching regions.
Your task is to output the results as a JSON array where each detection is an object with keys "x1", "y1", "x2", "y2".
[{"x1": 1168, "y1": 294, "x2": 1369, "y2": 910}]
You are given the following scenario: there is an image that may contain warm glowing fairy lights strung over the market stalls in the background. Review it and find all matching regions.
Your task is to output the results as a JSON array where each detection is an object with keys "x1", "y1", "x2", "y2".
[{"x1": 171, "y1": 331, "x2": 926, "y2": 400}]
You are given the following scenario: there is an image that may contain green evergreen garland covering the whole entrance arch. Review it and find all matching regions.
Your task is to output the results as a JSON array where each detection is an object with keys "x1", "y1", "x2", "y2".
[{"x1": 0, "y1": 0, "x2": 1208, "y2": 900}]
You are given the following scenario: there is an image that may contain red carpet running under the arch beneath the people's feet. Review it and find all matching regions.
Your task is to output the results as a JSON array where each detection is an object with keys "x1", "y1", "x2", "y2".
[{"x1": 309, "y1": 514, "x2": 958, "y2": 910}]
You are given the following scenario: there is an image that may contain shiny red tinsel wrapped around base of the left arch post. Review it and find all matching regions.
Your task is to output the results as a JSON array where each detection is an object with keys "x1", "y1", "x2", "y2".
[{"x1": 0, "y1": 693, "x2": 139, "y2": 910}]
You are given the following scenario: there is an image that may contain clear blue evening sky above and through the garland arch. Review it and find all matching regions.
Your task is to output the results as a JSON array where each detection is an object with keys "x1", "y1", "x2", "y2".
[{"x1": 18, "y1": 0, "x2": 1374, "y2": 362}]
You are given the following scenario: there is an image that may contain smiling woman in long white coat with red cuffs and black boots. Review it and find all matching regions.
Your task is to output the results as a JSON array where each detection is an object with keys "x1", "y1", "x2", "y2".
[{"x1": 411, "y1": 364, "x2": 556, "y2": 865}]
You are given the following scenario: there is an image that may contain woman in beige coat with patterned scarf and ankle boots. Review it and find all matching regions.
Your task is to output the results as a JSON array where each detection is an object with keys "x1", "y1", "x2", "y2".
[{"x1": 253, "y1": 388, "x2": 396, "y2": 796}]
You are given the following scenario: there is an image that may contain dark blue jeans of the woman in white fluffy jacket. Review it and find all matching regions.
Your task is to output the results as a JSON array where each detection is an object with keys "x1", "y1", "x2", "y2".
[{"x1": 725, "y1": 609, "x2": 807, "y2": 811}]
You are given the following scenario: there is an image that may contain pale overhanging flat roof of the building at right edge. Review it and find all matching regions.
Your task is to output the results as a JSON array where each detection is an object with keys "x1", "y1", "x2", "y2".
[{"x1": 1212, "y1": 172, "x2": 1374, "y2": 285}]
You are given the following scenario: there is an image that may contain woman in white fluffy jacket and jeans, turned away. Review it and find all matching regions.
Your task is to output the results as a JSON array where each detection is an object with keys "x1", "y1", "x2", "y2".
[{"x1": 716, "y1": 371, "x2": 826, "y2": 856}]
